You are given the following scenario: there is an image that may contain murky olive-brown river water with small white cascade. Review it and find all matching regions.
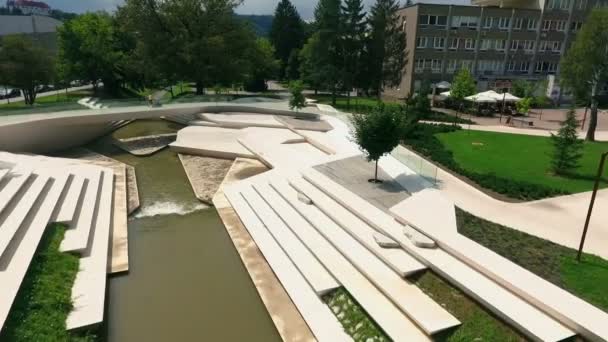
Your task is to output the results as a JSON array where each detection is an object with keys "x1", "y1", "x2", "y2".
[{"x1": 90, "y1": 120, "x2": 280, "y2": 342}]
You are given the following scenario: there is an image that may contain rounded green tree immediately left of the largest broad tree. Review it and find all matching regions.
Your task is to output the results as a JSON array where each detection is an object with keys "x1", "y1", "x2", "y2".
[{"x1": 58, "y1": 12, "x2": 125, "y2": 93}]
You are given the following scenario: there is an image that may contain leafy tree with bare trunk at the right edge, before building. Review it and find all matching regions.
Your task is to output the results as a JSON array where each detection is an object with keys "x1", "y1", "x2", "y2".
[{"x1": 560, "y1": 8, "x2": 608, "y2": 141}]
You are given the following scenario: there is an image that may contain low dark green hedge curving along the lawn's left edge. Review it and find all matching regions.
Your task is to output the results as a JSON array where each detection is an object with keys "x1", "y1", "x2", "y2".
[{"x1": 403, "y1": 123, "x2": 570, "y2": 201}]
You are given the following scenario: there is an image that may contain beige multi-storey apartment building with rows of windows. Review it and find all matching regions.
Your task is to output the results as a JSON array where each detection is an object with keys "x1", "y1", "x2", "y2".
[{"x1": 384, "y1": 0, "x2": 608, "y2": 98}]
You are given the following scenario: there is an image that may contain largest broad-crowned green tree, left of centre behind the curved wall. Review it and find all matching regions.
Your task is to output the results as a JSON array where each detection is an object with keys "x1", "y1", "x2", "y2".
[{"x1": 119, "y1": 0, "x2": 256, "y2": 94}]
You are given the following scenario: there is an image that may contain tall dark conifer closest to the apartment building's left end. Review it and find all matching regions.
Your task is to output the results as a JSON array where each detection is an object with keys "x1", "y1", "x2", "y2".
[{"x1": 368, "y1": 0, "x2": 407, "y2": 97}]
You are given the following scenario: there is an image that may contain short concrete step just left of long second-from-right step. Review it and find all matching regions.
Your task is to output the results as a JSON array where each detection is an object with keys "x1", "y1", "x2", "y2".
[{"x1": 292, "y1": 176, "x2": 426, "y2": 277}]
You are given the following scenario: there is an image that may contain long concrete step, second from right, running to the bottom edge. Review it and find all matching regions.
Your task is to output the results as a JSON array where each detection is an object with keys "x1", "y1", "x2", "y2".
[{"x1": 303, "y1": 170, "x2": 574, "y2": 341}]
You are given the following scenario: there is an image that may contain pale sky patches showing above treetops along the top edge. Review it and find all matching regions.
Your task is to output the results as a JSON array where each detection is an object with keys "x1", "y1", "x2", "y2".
[{"x1": 43, "y1": 0, "x2": 469, "y2": 19}]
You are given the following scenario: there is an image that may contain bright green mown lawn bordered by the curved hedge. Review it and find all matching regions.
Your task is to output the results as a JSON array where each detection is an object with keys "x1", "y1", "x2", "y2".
[{"x1": 436, "y1": 130, "x2": 608, "y2": 193}]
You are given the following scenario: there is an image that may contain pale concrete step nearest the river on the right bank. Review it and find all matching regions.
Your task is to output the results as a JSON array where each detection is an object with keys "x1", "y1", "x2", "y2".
[{"x1": 224, "y1": 187, "x2": 351, "y2": 341}]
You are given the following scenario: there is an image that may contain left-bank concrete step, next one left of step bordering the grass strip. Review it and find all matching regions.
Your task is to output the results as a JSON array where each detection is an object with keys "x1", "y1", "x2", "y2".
[{"x1": 0, "y1": 174, "x2": 55, "y2": 258}]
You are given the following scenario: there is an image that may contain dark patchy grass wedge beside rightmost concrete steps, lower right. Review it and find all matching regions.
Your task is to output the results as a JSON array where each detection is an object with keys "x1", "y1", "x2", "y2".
[{"x1": 456, "y1": 209, "x2": 608, "y2": 312}]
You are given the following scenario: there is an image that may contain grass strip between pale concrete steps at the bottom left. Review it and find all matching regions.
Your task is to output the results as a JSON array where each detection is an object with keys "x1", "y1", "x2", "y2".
[{"x1": 0, "y1": 224, "x2": 97, "y2": 342}]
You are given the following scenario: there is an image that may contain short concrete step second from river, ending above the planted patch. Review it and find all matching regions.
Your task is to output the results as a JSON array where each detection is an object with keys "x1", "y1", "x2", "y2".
[{"x1": 241, "y1": 185, "x2": 340, "y2": 295}]
